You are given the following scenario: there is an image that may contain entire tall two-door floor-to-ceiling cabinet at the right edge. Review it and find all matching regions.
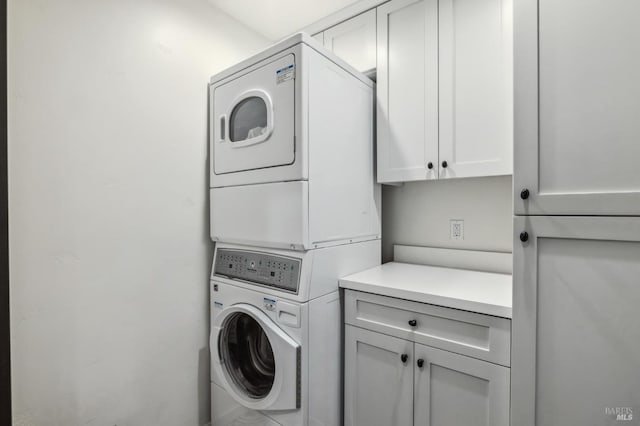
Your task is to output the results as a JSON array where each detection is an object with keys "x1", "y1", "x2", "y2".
[{"x1": 511, "y1": 0, "x2": 640, "y2": 426}]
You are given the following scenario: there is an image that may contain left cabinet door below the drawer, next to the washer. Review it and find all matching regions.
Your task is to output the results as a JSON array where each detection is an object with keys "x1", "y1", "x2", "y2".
[{"x1": 345, "y1": 325, "x2": 413, "y2": 426}]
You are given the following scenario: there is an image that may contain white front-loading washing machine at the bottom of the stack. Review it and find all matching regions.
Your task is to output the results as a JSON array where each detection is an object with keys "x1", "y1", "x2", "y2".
[{"x1": 210, "y1": 240, "x2": 380, "y2": 426}]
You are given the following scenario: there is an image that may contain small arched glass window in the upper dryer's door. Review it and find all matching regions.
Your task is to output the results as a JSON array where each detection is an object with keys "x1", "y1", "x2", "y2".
[{"x1": 229, "y1": 96, "x2": 267, "y2": 142}]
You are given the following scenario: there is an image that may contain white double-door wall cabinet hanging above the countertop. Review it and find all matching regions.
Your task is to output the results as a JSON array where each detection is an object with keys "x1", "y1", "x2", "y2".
[{"x1": 377, "y1": 0, "x2": 513, "y2": 182}]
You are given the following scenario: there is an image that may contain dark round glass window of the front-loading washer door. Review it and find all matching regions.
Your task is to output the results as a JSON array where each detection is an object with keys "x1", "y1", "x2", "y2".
[{"x1": 218, "y1": 312, "x2": 276, "y2": 399}]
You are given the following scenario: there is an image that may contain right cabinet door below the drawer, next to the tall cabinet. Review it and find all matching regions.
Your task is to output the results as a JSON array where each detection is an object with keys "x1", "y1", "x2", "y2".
[{"x1": 414, "y1": 343, "x2": 510, "y2": 426}]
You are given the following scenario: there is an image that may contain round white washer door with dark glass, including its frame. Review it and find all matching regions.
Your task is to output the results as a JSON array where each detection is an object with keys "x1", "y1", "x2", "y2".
[{"x1": 211, "y1": 304, "x2": 300, "y2": 410}]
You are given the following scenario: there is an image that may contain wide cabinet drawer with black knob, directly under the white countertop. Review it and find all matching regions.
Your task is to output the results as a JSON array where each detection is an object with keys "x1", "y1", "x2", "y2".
[{"x1": 345, "y1": 290, "x2": 511, "y2": 366}]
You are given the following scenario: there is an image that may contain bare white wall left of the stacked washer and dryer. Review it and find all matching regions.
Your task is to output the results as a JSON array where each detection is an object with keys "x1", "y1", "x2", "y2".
[{"x1": 8, "y1": 0, "x2": 266, "y2": 426}]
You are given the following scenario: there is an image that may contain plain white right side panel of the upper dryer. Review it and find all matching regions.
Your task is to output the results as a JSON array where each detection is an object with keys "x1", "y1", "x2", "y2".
[{"x1": 308, "y1": 47, "x2": 380, "y2": 245}]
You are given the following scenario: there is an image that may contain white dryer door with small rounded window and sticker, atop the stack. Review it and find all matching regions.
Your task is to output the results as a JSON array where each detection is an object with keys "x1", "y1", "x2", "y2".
[{"x1": 212, "y1": 54, "x2": 295, "y2": 175}]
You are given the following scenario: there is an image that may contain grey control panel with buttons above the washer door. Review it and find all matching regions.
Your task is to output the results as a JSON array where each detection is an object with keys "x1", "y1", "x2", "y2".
[{"x1": 213, "y1": 249, "x2": 300, "y2": 293}]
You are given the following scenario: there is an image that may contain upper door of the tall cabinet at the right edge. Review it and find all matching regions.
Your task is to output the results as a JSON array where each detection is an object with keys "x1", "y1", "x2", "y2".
[{"x1": 514, "y1": 0, "x2": 640, "y2": 216}]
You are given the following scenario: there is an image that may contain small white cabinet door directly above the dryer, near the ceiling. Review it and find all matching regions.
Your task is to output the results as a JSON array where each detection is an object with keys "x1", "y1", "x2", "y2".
[{"x1": 324, "y1": 9, "x2": 376, "y2": 71}]
